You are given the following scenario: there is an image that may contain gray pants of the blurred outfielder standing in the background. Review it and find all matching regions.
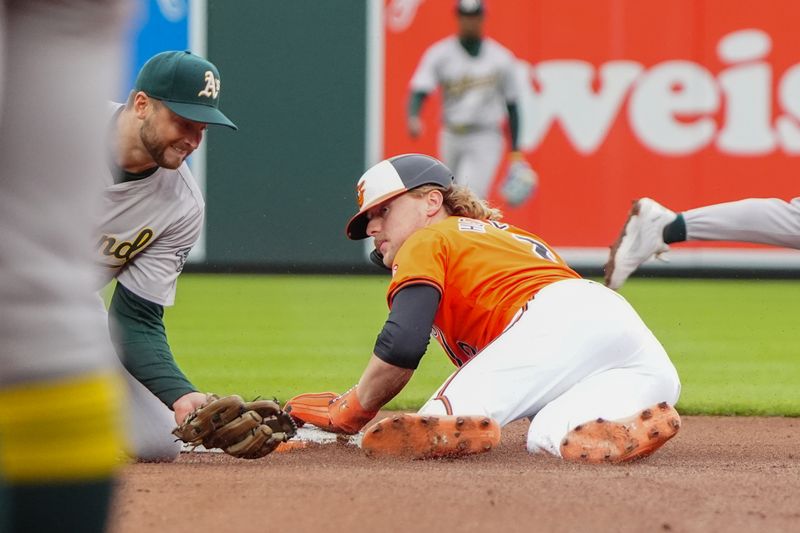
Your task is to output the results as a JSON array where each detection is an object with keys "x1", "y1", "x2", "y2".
[{"x1": 439, "y1": 128, "x2": 505, "y2": 199}]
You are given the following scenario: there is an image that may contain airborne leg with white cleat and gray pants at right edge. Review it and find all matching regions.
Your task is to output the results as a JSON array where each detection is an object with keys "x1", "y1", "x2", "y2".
[{"x1": 605, "y1": 197, "x2": 800, "y2": 289}]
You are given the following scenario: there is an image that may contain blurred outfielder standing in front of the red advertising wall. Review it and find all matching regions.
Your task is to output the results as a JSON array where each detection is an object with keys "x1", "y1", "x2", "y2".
[{"x1": 408, "y1": 0, "x2": 535, "y2": 205}]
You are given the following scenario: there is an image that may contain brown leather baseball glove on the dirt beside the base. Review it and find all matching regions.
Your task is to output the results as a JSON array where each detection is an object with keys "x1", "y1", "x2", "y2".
[{"x1": 172, "y1": 394, "x2": 297, "y2": 459}]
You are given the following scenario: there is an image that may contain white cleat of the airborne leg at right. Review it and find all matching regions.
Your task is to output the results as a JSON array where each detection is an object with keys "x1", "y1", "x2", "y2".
[{"x1": 603, "y1": 198, "x2": 677, "y2": 290}]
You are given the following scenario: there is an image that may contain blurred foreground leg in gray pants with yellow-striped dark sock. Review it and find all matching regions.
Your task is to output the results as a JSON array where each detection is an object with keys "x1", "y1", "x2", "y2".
[{"x1": 0, "y1": 0, "x2": 130, "y2": 533}]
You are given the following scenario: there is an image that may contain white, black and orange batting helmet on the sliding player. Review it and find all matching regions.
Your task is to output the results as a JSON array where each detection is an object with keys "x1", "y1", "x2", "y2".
[{"x1": 346, "y1": 154, "x2": 453, "y2": 240}]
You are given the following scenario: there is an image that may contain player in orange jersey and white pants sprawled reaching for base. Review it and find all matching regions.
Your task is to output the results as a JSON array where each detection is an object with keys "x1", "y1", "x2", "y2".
[{"x1": 287, "y1": 154, "x2": 680, "y2": 463}]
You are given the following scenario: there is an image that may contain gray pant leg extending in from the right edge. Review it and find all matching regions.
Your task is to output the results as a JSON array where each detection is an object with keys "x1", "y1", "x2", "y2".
[{"x1": 683, "y1": 197, "x2": 800, "y2": 249}]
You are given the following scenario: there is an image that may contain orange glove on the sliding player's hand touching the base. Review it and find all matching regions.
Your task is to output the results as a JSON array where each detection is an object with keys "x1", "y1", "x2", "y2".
[{"x1": 284, "y1": 387, "x2": 378, "y2": 434}]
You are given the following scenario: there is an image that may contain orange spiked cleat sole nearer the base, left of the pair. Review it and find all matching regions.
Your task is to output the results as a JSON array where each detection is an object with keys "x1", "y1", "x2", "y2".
[{"x1": 361, "y1": 414, "x2": 500, "y2": 459}]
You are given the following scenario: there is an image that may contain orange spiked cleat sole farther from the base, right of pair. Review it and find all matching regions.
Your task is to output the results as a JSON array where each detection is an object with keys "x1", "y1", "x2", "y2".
[{"x1": 561, "y1": 402, "x2": 681, "y2": 464}]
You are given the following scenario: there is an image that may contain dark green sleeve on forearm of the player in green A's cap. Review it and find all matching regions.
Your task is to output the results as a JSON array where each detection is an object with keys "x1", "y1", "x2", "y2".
[{"x1": 108, "y1": 283, "x2": 197, "y2": 409}]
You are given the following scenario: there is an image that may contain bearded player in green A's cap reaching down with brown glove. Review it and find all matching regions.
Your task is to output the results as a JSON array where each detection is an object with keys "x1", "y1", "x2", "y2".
[{"x1": 101, "y1": 51, "x2": 294, "y2": 461}]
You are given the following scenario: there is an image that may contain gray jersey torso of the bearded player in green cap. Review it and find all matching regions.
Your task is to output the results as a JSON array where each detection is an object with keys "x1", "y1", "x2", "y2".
[{"x1": 96, "y1": 104, "x2": 205, "y2": 306}]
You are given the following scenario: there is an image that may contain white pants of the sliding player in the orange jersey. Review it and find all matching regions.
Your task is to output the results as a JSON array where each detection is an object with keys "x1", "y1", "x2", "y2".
[{"x1": 420, "y1": 280, "x2": 681, "y2": 456}]
